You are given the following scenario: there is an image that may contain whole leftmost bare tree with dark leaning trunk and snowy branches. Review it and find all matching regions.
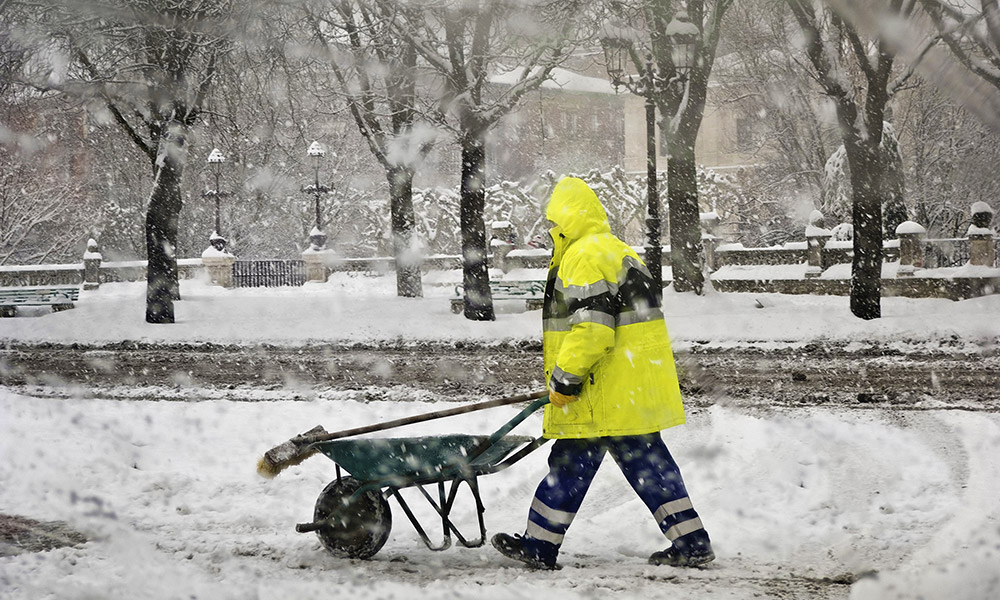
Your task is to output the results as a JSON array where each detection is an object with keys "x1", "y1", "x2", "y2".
[{"x1": 28, "y1": 0, "x2": 233, "y2": 323}]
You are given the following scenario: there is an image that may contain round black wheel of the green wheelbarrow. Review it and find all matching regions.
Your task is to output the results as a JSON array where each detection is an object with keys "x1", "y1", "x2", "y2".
[{"x1": 313, "y1": 477, "x2": 392, "y2": 559}]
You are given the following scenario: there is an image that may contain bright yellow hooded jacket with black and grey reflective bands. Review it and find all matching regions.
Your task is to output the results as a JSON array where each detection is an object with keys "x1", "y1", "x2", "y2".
[{"x1": 542, "y1": 177, "x2": 684, "y2": 439}]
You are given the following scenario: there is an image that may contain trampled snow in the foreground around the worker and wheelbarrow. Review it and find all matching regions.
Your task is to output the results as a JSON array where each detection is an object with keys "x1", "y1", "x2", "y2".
[{"x1": 0, "y1": 389, "x2": 1000, "y2": 600}]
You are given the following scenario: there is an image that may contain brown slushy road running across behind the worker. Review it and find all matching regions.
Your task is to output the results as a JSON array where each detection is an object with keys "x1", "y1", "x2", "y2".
[{"x1": 0, "y1": 342, "x2": 1000, "y2": 411}]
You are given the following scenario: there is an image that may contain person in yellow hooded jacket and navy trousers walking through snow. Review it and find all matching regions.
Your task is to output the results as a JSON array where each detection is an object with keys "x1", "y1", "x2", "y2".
[{"x1": 492, "y1": 177, "x2": 715, "y2": 569}]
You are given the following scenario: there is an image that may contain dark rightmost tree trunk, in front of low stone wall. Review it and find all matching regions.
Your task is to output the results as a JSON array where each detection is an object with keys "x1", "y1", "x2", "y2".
[{"x1": 846, "y1": 144, "x2": 883, "y2": 320}]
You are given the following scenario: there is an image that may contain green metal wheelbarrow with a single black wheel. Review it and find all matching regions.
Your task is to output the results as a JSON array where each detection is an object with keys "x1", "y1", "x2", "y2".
[{"x1": 286, "y1": 394, "x2": 549, "y2": 559}]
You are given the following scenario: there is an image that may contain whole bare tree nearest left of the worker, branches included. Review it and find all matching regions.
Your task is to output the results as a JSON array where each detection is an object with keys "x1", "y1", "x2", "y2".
[{"x1": 392, "y1": 0, "x2": 580, "y2": 321}]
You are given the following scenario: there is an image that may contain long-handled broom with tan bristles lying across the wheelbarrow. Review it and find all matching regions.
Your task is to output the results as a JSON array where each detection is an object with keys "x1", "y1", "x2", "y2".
[{"x1": 257, "y1": 391, "x2": 548, "y2": 479}]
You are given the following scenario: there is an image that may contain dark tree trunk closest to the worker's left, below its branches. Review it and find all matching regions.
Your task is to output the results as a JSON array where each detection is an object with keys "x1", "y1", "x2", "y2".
[{"x1": 460, "y1": 132, "x2": 496, "y2": 321}]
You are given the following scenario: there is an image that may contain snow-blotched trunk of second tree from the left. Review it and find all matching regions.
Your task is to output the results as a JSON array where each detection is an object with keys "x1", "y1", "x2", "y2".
[{"x1": 386, "y1": 167, "x2": 424, "y2": 298}]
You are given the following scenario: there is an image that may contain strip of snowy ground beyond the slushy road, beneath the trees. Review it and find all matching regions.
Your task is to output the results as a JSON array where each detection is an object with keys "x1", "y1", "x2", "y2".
[{"x1": 0, "y1": 272, "x2": 1000, "y2": 348}]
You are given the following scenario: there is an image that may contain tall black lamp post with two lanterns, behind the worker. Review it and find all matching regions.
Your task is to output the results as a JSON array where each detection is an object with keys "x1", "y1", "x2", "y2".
[{"x1": 601, "y1": 11, "x2": 700, "y2": 296}]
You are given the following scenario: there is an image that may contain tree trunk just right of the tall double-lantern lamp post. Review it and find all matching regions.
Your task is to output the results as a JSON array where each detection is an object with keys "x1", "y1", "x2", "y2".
[{"x1": 667, "y1": 139, "x2": 705, "y2": 294}]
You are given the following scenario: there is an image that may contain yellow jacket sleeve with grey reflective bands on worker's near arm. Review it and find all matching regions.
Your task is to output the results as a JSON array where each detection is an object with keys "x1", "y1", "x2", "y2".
[{"x1": 549, "y1": 247, "x2": 616, "y2": 396}]
